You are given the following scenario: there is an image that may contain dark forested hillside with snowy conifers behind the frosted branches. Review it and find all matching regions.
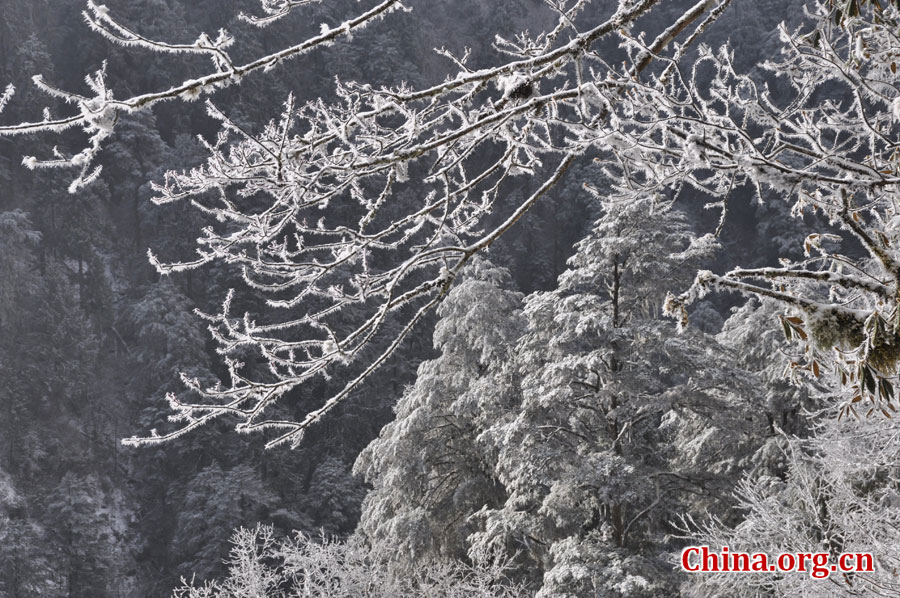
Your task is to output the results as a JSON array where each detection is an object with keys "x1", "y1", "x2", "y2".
[{"x1": 0, "y1": 0, "x2": 888, "y2": 598}]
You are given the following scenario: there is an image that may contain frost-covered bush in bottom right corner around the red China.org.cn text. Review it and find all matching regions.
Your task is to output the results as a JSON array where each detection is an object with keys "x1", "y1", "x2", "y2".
[{"x1": 683, "y1": 418, "x2": 900, "y2": 598}]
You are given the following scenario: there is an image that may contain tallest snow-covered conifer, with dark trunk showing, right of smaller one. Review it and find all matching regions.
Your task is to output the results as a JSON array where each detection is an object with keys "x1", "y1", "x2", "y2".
[{"x1": 469, "y1": 199, "x2": 764, "y2": 597}]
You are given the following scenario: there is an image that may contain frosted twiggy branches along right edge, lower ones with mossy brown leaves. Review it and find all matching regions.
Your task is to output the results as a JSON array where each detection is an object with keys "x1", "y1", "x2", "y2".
[{"x1": 640, "y1": 2, "x2": 900, "y2": 417}]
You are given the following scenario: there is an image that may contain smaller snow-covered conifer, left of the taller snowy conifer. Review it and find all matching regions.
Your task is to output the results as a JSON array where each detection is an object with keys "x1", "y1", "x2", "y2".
[{"x1": 355, "y1": 258, "x2": 522, "y2": 569}]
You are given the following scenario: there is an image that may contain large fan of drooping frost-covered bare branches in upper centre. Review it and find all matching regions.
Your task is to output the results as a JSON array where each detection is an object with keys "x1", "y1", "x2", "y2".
[{"x1": 119, "y1": 0, "x2": 728, "y2": 446}]
